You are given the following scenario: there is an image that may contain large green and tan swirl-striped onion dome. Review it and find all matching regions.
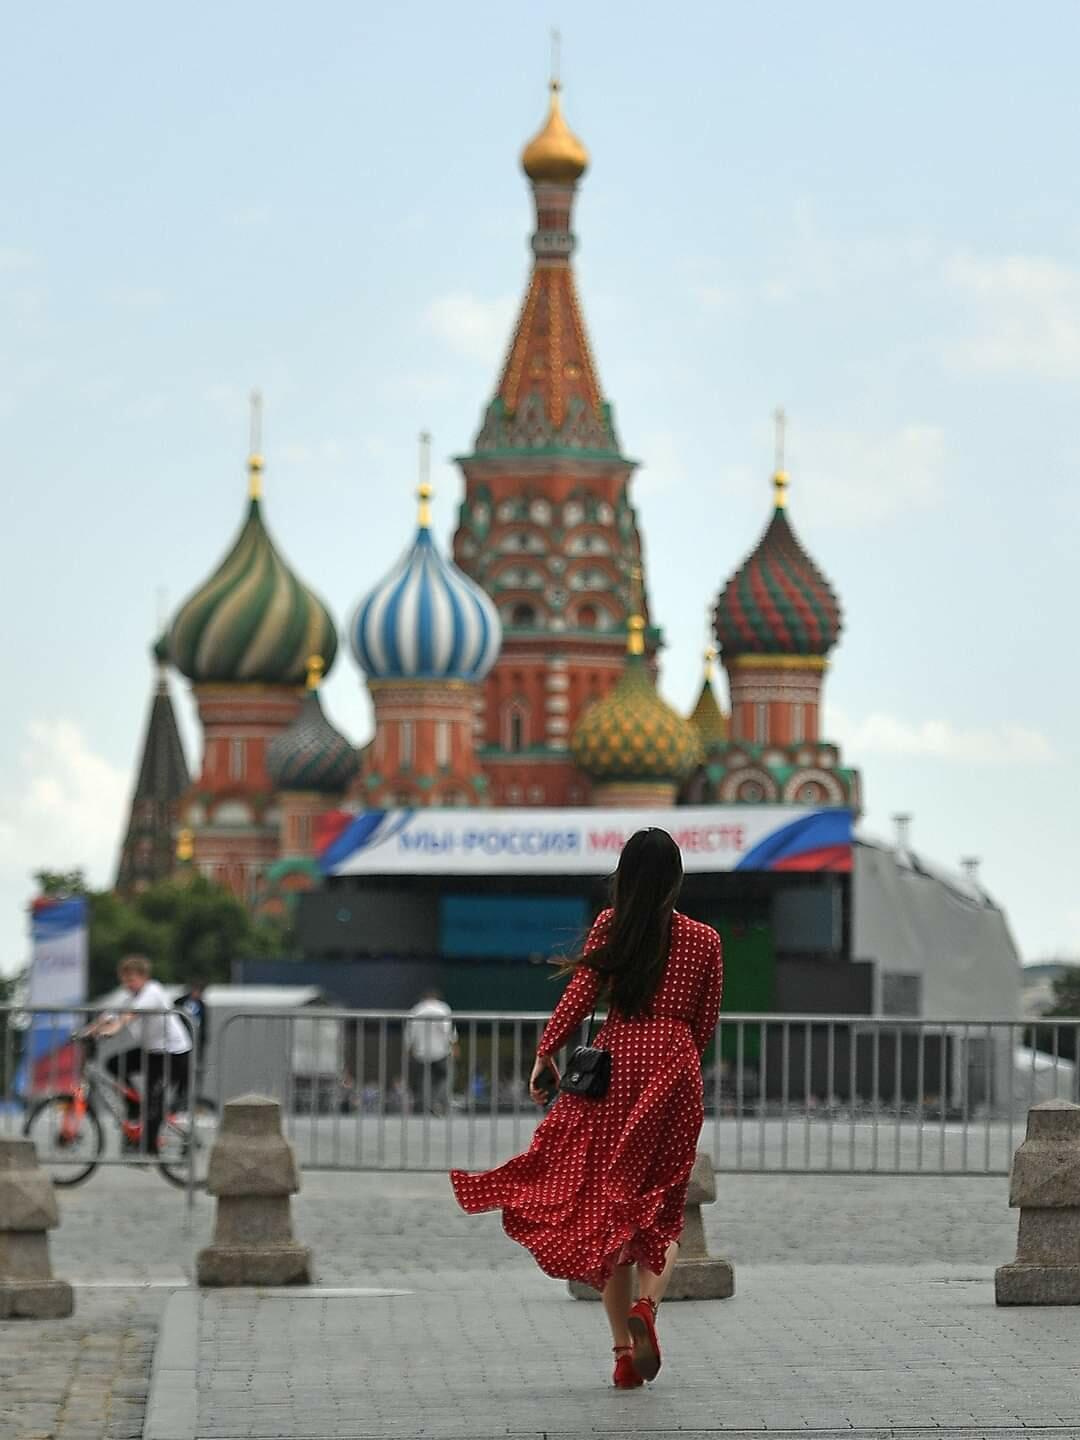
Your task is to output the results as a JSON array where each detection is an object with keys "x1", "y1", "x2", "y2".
[{"x1": 168, "y1": 498, "x2": 337, "y2": 685}]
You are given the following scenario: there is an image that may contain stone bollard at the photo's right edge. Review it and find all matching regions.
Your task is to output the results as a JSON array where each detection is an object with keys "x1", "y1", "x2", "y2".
[{"x1": 994, "y1": 1100, "x2": 1080, "y2": 1305}]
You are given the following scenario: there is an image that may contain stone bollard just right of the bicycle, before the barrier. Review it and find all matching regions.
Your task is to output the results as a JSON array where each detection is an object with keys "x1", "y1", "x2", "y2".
[{"x1": 196, "y1": 1094, "x2": 311, "y2": 1286}]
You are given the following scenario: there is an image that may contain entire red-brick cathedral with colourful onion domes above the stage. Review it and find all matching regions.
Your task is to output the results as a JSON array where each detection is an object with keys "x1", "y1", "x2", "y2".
[{"x1": 118, "y1": 82, "x2": 861, "y2": 903}]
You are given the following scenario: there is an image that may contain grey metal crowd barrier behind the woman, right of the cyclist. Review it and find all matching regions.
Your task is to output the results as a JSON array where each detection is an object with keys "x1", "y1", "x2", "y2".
[{"x1": 207, "y1": 1008, "x2": 1080, "y2": 1175}]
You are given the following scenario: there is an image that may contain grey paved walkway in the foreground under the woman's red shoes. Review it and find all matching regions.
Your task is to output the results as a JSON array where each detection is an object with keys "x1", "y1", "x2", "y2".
[{"x1": 151, "y1": 1266, "x2": 1080, "y2": 1440}]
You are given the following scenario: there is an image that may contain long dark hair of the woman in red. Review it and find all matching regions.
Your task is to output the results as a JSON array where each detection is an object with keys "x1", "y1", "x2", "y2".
[{"x1": 575, "y1": 828, "x2": 683, "y2": 1018}]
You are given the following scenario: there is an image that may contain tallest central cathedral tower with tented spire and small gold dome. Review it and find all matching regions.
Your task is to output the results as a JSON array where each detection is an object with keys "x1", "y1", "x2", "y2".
[{"x1": 454, "y1": 81, "x2": 658, "y2": 805}]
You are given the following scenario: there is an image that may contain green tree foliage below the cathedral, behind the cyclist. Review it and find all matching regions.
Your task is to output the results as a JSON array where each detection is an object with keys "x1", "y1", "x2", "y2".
[{"x1": 36, "y1": 870, "x2": 287, "y2": 996}]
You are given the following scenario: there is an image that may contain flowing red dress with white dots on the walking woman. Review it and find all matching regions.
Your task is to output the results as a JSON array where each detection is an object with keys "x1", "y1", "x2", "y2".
[{"x1": 451, "y1": 910, "x2": 723, "y2": 1290}]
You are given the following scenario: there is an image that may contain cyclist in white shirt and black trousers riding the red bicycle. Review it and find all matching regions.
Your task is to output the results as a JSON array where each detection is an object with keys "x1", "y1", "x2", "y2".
[{"x1": 88, "y1": 955, "x2": 192, "y2": 1155}]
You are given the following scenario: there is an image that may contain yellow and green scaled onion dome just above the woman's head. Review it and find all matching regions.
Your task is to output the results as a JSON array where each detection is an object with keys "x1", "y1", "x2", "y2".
[{"x1": 570, "y1": 655, "x2": 703, "y2": 780}]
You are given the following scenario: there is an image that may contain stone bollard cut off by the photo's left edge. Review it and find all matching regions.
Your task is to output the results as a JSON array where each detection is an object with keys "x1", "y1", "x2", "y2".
[{"x1": 0, "y1": 1140, "x2": 75, "y2": 1320}]
